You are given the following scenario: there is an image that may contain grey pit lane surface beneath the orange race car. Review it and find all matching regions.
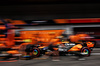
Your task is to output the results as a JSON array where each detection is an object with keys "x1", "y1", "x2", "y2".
[{"x1": 0, "y1": 56, "x2": 100, "y2": 66}]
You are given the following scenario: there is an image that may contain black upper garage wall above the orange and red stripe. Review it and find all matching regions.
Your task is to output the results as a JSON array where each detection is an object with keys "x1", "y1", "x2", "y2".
[{"x1": 0, "y1": 3, "x2": 100, "y2": 20}]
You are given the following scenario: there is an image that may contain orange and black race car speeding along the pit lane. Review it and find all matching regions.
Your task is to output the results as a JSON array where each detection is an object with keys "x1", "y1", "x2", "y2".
[{"x1": 20, "y1": 34, "x2": 95, "y2": 57}]
